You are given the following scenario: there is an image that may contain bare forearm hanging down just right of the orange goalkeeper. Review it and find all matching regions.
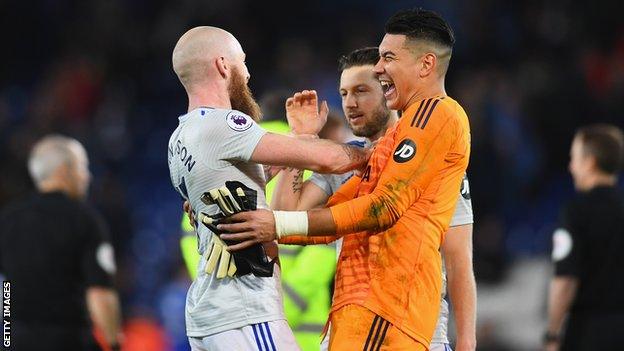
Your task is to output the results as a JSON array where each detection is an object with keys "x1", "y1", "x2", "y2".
[{"x1": 442, "y1": 224, "x2": 477, "y2": 351}]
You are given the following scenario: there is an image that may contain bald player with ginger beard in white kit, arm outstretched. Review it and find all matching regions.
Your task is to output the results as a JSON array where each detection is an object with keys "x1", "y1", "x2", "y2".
[{"x1": 168, "y1": 27, "x2": 368, "y2": 351}]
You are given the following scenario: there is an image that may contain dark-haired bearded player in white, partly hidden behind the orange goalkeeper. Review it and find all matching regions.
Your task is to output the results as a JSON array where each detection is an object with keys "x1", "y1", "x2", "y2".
[{"x1": 273, "y1": 47, "x2": 476, "y2": 351}]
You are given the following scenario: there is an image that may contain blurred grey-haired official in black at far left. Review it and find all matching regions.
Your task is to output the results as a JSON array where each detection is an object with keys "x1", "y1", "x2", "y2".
[{"x1": 0, "y1": 135, "x2": 120, "y2": 351}]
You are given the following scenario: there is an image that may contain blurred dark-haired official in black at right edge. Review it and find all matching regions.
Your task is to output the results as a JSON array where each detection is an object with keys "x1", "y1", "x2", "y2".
[{"x1": 544, "y1": 124, "x2": 624, "y2": 351}]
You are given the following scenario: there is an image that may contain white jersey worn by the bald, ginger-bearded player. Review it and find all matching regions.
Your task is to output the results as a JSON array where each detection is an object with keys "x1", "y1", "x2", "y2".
[{"x1": 168, "y1": 108, "x2": 285, "y2": 337}]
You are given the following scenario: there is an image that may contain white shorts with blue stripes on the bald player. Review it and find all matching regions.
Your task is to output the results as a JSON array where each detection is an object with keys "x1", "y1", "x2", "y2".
[{"x1": 189, "y1": 319, "x2": 301, "y2": 351}]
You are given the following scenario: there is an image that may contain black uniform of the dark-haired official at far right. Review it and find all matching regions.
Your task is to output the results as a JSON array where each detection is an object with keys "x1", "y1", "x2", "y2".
[{"x1": 553, "y1": 186, "x2": 624, "y2": 350}]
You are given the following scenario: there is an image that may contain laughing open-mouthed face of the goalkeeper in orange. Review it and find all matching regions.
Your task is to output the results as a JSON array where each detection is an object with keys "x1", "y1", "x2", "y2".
[{"x1": 374, "y1": 34, "x2": 421, "y2": 110}]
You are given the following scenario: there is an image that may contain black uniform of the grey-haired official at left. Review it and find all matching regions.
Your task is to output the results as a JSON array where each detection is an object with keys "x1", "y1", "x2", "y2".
[{"x1": 0, "y1": 192, "x2": 115, "y2": 351}]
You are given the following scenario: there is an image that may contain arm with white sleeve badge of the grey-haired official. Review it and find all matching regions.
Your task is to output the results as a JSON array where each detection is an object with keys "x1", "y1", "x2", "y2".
[{"x1": 82, "y1": 210, "x2": 121, "y2": 350}]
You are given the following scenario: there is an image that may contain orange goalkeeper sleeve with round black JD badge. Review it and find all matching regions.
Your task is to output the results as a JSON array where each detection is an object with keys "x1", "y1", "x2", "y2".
[{"x1": 330, "y1": 104, "x2": 460, "y2": 235}]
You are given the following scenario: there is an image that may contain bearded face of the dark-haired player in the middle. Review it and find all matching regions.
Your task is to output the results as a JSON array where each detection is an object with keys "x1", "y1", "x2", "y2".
[{"x1": 340, "y1": 65, "x2": 390, "y2": 138}]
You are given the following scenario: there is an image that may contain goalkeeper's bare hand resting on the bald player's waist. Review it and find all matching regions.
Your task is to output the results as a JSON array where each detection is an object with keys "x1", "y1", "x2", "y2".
[{"x1": 217, "y1": 210, "x2": 277, "y2": 251}]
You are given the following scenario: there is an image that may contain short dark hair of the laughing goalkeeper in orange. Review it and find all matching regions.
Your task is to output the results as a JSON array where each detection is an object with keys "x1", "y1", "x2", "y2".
[{"x1": 385, "y1": 8, "x2": 455, "y2": 48}]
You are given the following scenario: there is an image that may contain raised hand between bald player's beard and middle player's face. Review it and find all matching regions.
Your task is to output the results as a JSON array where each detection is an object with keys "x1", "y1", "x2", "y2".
[{"x1": 286, "y1": 90, "x2": 329, "y2": 134}]
